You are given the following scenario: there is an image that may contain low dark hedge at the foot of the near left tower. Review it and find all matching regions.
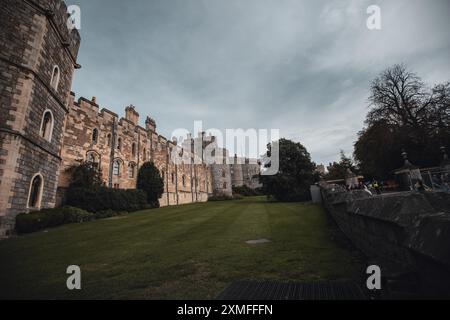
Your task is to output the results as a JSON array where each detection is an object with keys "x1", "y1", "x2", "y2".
[{"x1": 16, "y1": 207, "x2": 94, "y2": 233}]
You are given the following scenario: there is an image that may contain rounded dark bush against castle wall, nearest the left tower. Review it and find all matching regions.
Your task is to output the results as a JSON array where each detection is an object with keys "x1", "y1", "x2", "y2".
[{"x1": 67, "y1": 162, "x2": 103, "y2": 189}]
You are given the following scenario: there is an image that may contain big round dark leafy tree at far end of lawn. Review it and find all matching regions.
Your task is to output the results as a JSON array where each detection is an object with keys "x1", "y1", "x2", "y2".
[{"x1": 260, "y1": 139, "x2": 318, "y2": 201}]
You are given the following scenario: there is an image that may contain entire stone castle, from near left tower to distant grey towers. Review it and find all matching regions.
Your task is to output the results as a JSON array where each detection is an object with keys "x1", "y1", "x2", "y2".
[{"x1": 0, "y1": 0, "x2": 259, "y2": 237}]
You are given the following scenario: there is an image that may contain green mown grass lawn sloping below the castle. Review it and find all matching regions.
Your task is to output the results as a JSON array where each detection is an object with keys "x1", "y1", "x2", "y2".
[{"x1": 0, "y1": 197, "x2": 362, "y2": 299}]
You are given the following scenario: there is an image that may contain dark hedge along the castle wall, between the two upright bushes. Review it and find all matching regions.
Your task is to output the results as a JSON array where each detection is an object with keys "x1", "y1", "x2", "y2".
[{"x1": 67, "y1": 187, "x2": 149, "y2": 216}]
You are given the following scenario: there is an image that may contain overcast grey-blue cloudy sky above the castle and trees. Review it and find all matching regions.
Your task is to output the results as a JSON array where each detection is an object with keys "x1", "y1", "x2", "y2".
[{"x1": 67, "y1": 0, "x2": 450, "y2": 163}]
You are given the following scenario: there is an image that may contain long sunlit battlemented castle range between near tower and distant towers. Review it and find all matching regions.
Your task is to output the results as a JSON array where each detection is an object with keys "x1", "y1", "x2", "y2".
[{"x1": 58, "y1": 95, "x2": 212, "y2": 206}]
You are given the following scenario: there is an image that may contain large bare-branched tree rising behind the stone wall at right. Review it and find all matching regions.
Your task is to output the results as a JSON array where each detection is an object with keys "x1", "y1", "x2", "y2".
[{"x1": 354, "y1": 65, "x2": 450, "y2": 179}]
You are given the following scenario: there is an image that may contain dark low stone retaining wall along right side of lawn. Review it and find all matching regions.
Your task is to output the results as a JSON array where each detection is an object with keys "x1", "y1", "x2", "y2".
[{"x1": 321, "y1": 185, "x2": 450, "y2": 297}]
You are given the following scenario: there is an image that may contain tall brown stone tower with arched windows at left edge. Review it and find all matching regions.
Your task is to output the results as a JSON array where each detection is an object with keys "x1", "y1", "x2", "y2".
[{"x1": 0, "y1": 0, "x2": 80, "y2": 236}]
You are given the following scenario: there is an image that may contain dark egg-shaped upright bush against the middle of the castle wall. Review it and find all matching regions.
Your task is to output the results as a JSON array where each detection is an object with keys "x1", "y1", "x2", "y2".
[{"x1": 136, "y1": 161, "x2": 164, "y2": 207}]
